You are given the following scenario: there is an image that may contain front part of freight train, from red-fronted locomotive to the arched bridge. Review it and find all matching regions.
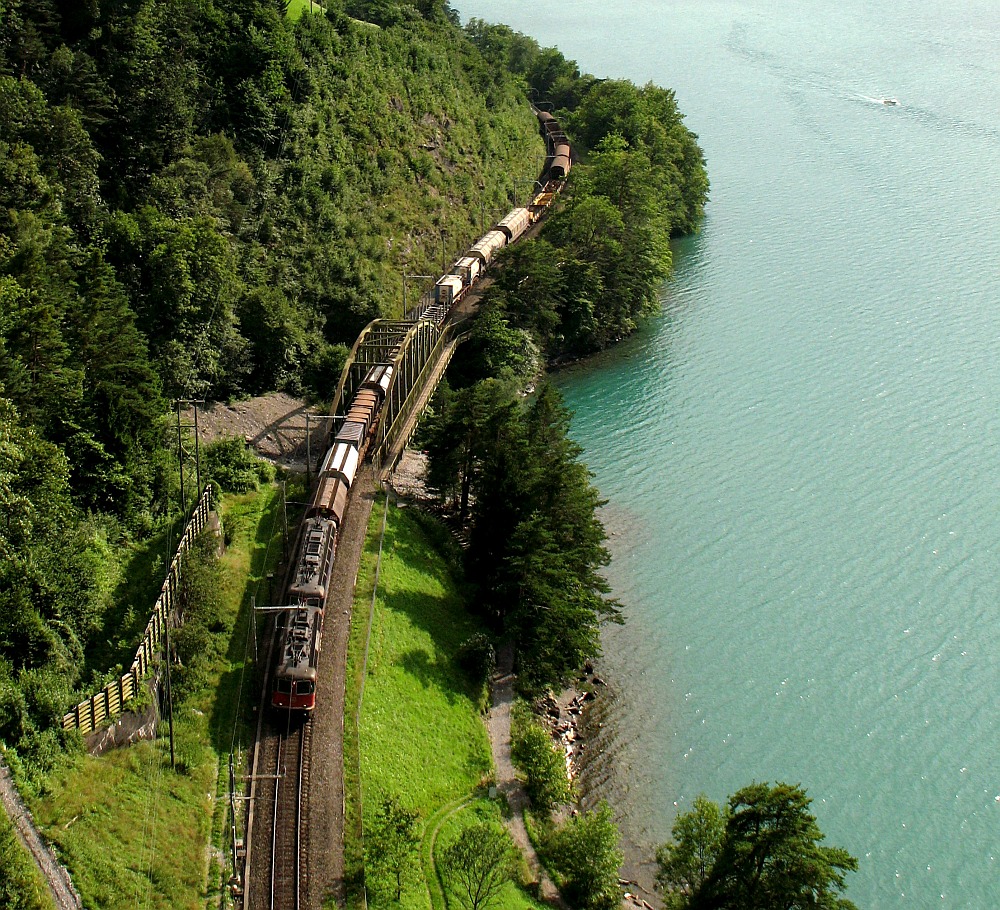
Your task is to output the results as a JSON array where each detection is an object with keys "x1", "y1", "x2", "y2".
[{"x1": 271, "y1": 363, "x2": 393, "y2": 712}]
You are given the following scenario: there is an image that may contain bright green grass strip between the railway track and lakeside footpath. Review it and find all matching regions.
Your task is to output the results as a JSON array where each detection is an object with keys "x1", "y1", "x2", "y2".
[{"x1": 344, "y1": 505, "x2": 538, "y2": 910}]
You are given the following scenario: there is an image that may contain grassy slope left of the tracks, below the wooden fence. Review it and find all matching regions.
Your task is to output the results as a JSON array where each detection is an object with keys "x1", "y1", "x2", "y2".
[{"x1": 32, "y1": 486, "x2": 291, "y2": 910}]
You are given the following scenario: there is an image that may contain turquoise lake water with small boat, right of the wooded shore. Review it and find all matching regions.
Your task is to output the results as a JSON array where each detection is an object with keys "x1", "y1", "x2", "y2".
[{"x1": 457, "y1": 0, "x2": 1000, "y2": 910}]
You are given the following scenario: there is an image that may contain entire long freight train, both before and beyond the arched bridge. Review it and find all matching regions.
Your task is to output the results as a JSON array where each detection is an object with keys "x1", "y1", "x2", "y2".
[{"x1": 271, "y1": 111, "x2": 572, "y2": 712}]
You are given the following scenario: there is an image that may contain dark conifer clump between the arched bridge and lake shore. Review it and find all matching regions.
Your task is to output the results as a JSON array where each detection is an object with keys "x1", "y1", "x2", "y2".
[{"x1": 429, "y1": 379, "x2": 619, "y2": 688}]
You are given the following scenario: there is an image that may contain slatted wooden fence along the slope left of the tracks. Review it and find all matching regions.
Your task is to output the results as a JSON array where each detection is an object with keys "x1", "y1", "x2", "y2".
[{"x1": 63, "y1": 486, "x2": 212, "y2": 733}]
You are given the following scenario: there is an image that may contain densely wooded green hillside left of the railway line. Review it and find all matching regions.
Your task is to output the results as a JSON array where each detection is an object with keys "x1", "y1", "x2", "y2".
[{"x1": 0, "y1": 0, "x2": 543, "y2": 778}]
